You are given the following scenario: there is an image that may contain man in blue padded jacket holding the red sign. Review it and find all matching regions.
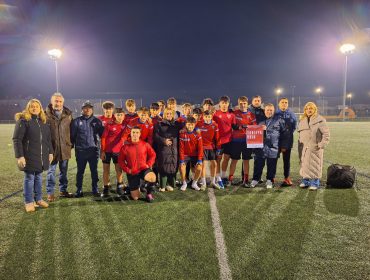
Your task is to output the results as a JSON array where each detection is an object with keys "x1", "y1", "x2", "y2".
[{"x1": 250, "y1": 103, "x2": 285, "y2": 189}]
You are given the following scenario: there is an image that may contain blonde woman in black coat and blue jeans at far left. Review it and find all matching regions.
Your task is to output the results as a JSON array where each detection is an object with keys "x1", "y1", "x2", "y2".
[{"x1": 13, "y1": 99, "x2": 53, "y2": 212}]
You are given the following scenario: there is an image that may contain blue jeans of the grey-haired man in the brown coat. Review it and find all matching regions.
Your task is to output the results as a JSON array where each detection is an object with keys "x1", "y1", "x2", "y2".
[{"x1": 46, "y1": 159, "x2": 68, "y2": 194}]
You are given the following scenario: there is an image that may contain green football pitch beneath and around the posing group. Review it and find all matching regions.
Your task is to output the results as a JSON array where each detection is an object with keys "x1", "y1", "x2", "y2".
[{"x1": 0, "y1": 122, "x2": 370, "y2": 280}]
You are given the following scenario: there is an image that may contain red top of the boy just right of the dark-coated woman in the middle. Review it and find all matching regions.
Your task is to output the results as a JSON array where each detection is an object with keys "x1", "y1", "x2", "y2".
[{"x1": 179, "y1": 129, "x2": 203, "y2": 161}]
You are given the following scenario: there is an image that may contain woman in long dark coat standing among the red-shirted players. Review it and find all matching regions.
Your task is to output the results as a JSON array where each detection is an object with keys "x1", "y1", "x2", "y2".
[{"x1": 154, "y1": 108, "x2": 183, "y2": 192}]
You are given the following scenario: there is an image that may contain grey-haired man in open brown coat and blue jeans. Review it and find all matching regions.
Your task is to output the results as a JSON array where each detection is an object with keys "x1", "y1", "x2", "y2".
[{"x1": 45, "y1": 92, "x2": 73, "y2": 202}]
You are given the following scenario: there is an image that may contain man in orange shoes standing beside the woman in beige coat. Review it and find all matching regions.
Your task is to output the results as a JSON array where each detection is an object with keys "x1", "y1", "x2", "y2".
[{"x1": 276, "y1": 97, "x2": 297, "y2": 187}]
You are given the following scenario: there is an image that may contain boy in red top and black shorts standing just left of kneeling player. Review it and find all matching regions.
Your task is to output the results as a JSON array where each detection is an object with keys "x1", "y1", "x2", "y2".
[{"x1": 100, "y1": 108, "x2": 126, "y2": 196}]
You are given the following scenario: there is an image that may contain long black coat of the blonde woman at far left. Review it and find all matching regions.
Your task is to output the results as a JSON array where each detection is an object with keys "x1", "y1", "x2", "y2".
[{"x1": 13, "y1": 114, "x2": 54, "y2": 172}]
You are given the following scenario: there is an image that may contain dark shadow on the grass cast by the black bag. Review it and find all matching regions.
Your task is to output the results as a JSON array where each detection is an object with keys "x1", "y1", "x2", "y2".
[{"x1": 324, "y1": 188, "x2": 360, "y2": 217}]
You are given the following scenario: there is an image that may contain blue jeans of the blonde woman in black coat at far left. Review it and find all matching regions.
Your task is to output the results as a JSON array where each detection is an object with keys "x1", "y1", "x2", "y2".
[{"x1": 23, "y1": 171, "x2": 42, "y2": 203}]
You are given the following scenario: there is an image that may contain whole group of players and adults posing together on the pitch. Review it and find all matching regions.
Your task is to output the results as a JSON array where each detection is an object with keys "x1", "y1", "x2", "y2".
[{"x1": 13, "y1": 93, "x2": 330, "y2": 212}]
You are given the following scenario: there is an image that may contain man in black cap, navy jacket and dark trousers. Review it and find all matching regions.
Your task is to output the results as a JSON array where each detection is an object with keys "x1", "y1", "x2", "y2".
[{"x1": 71, "y1": 101, "x2": 104, "y2": 197}]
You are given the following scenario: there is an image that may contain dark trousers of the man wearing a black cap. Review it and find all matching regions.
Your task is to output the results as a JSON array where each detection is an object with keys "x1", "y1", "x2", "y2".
[{"x1": 76, "y1": 148, "x2": 99, "y2": 193}]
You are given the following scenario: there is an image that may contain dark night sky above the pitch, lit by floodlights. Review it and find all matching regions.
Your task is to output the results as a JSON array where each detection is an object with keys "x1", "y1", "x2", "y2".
[{"x1": 0, "y1": 0, "x2": 370, "y2": 103}]
